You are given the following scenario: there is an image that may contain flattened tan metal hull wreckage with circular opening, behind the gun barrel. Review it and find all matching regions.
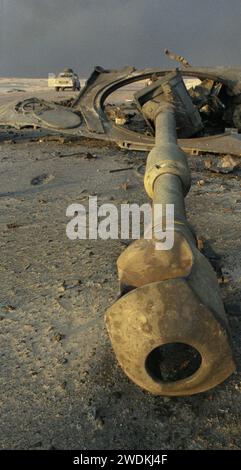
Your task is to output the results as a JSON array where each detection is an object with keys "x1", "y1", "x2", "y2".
[{"x1": 0, "y1": 67, "x2": 241, "y2": 155}]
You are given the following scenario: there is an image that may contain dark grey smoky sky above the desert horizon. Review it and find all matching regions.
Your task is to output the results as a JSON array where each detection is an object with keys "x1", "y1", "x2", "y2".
[{"x1": 0, "y1": 0, "x2": 241, "y2": 77}]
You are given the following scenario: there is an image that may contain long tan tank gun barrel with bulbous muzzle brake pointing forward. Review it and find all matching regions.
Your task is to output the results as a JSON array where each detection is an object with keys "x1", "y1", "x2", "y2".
[{"x1": 106, "y1": 97, "x2": 235, "y2": 396}]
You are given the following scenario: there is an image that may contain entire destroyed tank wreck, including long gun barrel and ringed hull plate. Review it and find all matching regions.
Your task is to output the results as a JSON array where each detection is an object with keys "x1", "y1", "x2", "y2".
[{"x1": 0, "y1": 57, "x2": 241, "y2": 396}]
